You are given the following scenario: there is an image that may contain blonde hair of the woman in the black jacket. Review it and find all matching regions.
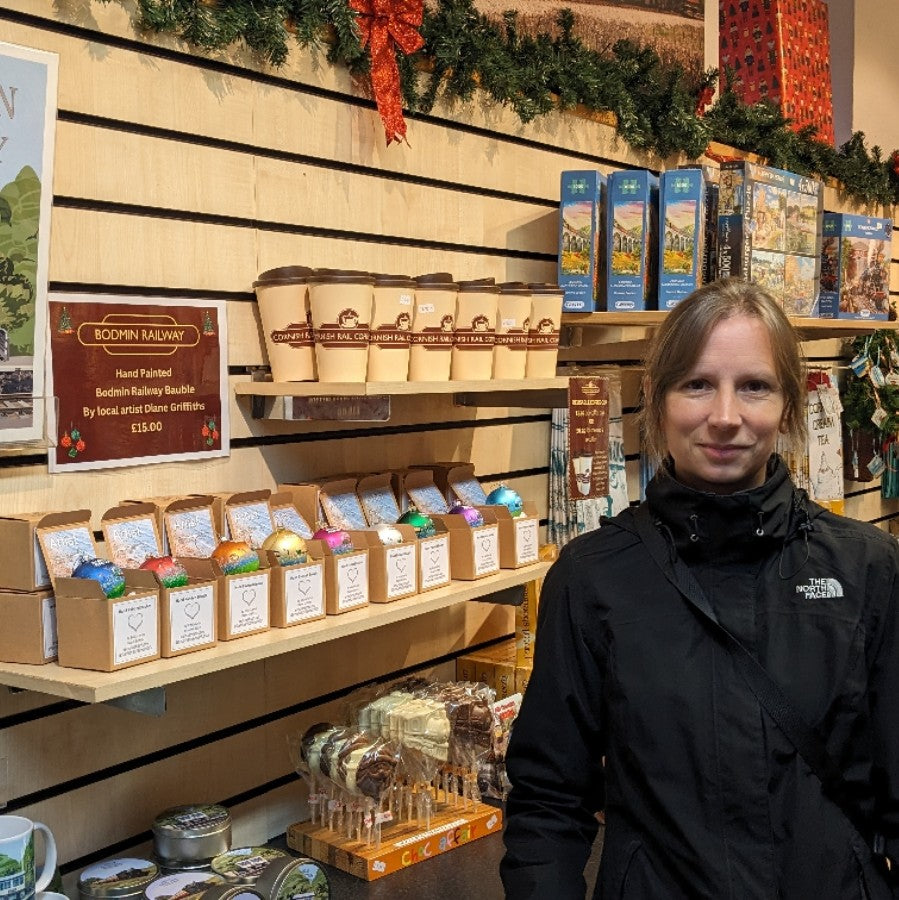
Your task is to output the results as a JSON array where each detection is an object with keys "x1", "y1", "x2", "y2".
[{"x1": 640, "y1": 278, "x2": 806, "y2": 462}]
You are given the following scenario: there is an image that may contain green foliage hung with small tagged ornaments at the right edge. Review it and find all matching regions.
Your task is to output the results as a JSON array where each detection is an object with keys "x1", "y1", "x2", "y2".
[{"x1": 842, "y1": 330, "x2": 899, "y2": 499}]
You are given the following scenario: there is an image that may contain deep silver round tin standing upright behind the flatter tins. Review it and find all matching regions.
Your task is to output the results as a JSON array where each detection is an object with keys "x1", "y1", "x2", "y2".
[{"x1": 153, "y1": 804, "x2": 231, "y2": 869}]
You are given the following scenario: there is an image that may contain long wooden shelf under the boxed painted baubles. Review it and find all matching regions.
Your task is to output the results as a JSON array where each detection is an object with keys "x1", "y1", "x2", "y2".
[{"x1": 0, "y1": 562, "x2": 550, "y2": 703}]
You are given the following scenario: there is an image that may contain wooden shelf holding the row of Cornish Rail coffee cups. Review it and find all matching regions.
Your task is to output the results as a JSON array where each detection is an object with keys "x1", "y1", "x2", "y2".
[{"x1": 234, "y1": 377, "x2": 568, "y2": 397}]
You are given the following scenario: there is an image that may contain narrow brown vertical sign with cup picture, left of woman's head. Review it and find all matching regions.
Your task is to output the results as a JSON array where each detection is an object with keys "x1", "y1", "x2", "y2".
[{"x1": 568, "y1": 375, "x2": 609, "y2": 500}]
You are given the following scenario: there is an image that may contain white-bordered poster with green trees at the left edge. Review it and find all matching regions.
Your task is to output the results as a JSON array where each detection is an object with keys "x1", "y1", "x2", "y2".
[{"x1": 0, "y1": 42, "x2": 58, "y2": 446}]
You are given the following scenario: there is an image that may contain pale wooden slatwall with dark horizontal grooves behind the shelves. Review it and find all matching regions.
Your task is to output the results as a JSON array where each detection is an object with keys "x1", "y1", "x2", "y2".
[{"x1": 0, "y1": 0, "x2": 899, "y2": 890}]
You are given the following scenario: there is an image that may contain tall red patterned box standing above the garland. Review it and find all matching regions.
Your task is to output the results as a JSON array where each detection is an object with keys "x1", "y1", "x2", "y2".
[{"x1": 718, "y1": 0, "x2": 834, "y2": 145}]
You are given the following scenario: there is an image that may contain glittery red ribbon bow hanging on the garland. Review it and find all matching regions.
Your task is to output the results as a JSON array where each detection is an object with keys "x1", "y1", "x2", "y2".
[{"x1": 350, "y1": 0, "x2": 424, "y2": 144}]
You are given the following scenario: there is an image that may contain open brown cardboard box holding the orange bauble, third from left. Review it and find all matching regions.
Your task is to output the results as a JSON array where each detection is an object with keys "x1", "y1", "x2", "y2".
[{"x1": 181, "y1": 557, "x2": 271, "y2": 641}]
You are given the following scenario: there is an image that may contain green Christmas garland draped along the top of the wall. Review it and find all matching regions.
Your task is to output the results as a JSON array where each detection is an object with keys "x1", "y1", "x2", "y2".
[{"x1": 104, "y1": 0, "x2": 899, "y2": 206}]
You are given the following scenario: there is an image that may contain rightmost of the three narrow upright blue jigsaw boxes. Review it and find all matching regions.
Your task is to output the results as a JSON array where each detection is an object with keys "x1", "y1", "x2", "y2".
[{"x1": 658, "y1": 168, "x2": 707, "y2": 310}]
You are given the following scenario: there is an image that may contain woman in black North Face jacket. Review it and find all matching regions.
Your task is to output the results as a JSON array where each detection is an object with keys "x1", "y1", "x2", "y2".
[{"x1": 502, "y1": 280, "x2": 899, "y2": 900}]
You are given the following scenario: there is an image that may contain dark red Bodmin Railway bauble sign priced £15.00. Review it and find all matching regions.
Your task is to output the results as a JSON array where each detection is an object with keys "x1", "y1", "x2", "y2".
[{"x1": 50, "y1": 294, "x2": 230, "y2": 472}]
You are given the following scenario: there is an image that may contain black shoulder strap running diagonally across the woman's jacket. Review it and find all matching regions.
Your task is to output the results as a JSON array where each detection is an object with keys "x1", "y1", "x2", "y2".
[{"x1": 634, "y1": 503, "x2": 870, "y2": 836}]
